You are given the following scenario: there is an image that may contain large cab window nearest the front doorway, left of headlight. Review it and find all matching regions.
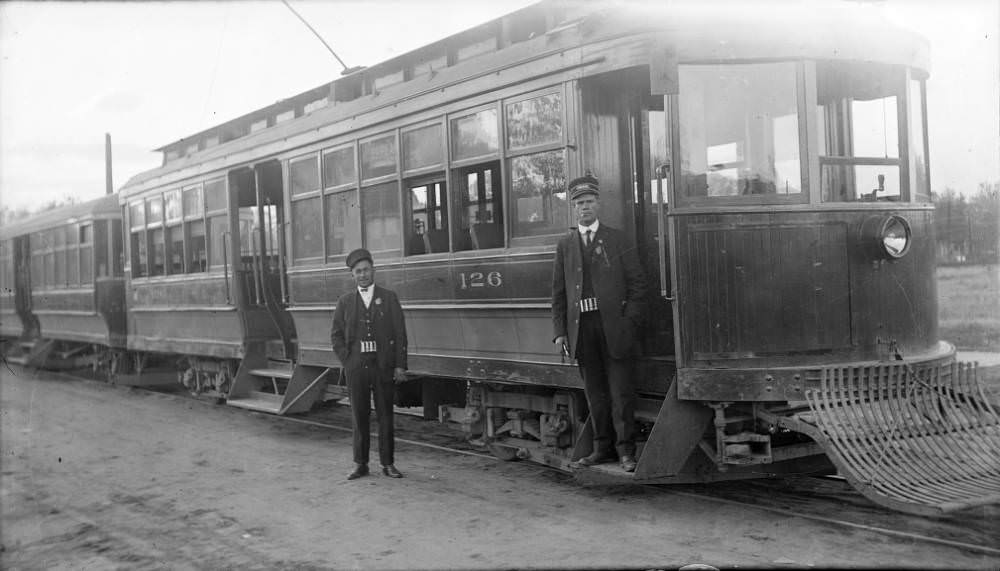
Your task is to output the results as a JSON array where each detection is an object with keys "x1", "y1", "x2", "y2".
[{"x1": 679, "y1": 63, "x2": 802, "y2": 198}]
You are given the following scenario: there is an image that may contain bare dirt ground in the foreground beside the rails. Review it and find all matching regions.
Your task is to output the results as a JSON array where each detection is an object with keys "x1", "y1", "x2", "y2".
[{"x1": 0, "y1": 367, "x2": 1000, "y2": 569}]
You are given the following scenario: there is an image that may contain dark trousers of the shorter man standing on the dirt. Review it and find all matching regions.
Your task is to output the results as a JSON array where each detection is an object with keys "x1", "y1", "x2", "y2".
[{"x1": 345, "y1": 360, "x2": 395, "y2": 466}]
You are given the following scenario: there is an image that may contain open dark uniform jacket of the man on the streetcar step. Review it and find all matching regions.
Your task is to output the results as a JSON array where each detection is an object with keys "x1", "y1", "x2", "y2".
[{"x1": 552, "y1": 222, "x2": 646, "y2": 359}]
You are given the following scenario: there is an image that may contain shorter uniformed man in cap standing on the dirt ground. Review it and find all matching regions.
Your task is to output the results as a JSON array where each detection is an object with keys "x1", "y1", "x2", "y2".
[{"x1": 331, "y1": 248, "x2": 406, "y2": 480}]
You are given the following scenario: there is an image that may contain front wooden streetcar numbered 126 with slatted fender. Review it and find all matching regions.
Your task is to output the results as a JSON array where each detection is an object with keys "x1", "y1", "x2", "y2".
[{"x1": 3, "y1": 1, "x2": 1000, "y2": 514}]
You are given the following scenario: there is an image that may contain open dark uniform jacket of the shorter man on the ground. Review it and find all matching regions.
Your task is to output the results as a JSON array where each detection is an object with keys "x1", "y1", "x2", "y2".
[{"x1": 330, "y1": 285, "x2": 406, "y2": 369}]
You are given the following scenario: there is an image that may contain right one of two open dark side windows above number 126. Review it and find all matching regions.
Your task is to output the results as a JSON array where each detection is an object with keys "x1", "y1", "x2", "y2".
[{"x1": 452, "y1": 161, "x2": 504, "y2": 250}]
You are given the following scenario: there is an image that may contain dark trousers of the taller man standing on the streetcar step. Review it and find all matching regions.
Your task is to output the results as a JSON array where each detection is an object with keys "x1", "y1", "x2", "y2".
[{"x1": 576, "y1": 311, "x2": 635, "y2": 456}]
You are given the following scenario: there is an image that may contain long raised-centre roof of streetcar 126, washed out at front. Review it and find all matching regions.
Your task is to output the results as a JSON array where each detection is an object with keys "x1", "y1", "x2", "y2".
[{"x1": 121, "y1": 0, "x2": 930, "y2": 201}]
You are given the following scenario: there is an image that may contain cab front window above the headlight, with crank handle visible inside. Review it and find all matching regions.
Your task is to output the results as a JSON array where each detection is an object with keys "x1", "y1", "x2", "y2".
[{"x1": 815, "y1": 62, "x2": 908, "y2": 202}]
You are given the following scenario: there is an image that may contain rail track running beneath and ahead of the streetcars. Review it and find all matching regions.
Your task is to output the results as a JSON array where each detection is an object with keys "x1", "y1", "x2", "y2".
[{"x1": 17, "y1": 366, "x2": 1000, "y2": 557}]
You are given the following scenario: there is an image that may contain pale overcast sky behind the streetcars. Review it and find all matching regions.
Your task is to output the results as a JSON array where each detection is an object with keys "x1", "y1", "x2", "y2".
[{"x1": 0, "y1": 0, "x2": 1000, "y2": 213}]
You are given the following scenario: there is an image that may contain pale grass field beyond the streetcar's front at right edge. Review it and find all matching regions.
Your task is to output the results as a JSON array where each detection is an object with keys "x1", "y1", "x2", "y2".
[{"x1": 937, "y1": 265, "x2": 1000, "y2": 352}]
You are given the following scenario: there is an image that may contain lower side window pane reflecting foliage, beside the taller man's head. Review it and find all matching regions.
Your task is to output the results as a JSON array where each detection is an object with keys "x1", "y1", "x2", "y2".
[{"x1": 510, "y1": 150, "x2": 569, "y2": 236}]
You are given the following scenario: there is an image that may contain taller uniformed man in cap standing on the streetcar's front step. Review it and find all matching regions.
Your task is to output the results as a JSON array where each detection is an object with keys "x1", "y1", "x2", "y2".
[{"x1": 552, "y1": 172, "x2": 646, "y2": 472}]
